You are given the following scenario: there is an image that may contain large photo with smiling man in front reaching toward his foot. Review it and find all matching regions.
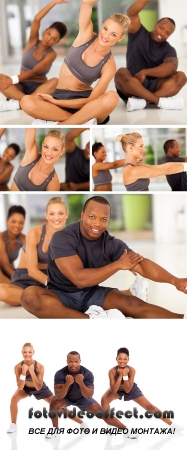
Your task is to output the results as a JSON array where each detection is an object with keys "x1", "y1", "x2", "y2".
[{"x1": 0, "y1": 192, "x2": 187, "y2": 319}]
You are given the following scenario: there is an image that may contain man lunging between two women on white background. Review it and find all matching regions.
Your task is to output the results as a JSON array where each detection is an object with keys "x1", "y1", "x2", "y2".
[{"x1": 45, "y1": 351, "x2": 138, "y2": 439}]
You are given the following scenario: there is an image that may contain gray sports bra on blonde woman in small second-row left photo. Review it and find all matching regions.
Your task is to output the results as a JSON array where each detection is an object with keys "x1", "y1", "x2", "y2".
[{"x1": 14, "y1": 155, "x2": 55, "y2": 191}]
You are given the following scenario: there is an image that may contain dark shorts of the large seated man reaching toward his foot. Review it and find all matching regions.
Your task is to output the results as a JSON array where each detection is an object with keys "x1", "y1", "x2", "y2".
[{"x1": 47, "y1": 286, "x2": 113, "y2": 312}]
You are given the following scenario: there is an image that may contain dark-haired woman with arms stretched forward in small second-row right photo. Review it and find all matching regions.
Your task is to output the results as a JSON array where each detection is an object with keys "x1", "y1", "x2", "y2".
[{"x1": 92, "y1": 142, "x2": 125, "y2": 191}]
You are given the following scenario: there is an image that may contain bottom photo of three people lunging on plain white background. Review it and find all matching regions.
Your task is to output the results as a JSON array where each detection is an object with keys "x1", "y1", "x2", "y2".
[{"x1": 0, "y1": 320, "x2": 187, "y2": 450}]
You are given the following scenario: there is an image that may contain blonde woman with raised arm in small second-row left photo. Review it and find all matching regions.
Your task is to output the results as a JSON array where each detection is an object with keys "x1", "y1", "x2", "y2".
[{"x1": 11, "y1": 128, "x2": 65, "y2": 191}]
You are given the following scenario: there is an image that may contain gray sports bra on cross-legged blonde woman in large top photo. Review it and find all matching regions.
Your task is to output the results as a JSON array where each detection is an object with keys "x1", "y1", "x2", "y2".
[{"x1": 64, "y1": 34, "x2": 111, "y2": 85}]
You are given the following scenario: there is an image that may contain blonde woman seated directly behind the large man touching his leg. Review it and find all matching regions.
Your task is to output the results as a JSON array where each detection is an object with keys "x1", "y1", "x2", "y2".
[{"x1": 0, "y1": 197, "x2": 68, "y2": 306}]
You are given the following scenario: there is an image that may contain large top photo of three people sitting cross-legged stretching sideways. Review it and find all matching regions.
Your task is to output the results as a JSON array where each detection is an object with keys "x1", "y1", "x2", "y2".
[{"x1": 0, "y1": 0, "x2": 187, "y2": 126}]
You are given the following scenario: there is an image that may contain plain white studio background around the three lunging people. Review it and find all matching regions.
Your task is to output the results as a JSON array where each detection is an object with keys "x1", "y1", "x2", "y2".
[{"x1": 0, "y1": 320, "x2": 187, "y2": 450}]
